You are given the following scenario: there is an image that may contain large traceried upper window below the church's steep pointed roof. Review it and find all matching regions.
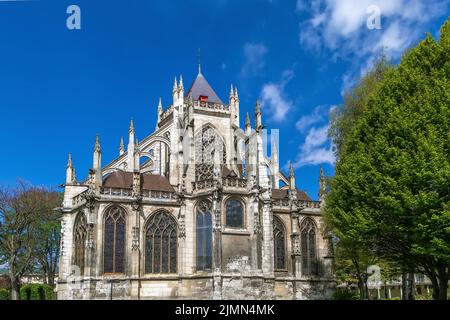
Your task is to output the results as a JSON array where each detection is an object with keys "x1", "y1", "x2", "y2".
[{"x1": 194, "y1": 126, "x2": 227, "y2": 181}]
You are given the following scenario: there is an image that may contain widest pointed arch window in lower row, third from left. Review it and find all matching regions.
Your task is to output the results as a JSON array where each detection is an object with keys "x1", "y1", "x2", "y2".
[{"x1": 145, "y1": 211, "x2": 177, "y2": 273}]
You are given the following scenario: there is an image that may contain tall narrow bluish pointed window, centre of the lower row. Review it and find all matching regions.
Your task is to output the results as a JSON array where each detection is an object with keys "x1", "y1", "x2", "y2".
[{"x1": 196, "y1": 200, "x2": 212, "y2": 271}]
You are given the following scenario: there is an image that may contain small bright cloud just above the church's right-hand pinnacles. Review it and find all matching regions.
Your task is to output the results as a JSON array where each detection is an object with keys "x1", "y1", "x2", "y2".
[{"x1": 261, "y1": 70, "x2": 294, "y2": 122}]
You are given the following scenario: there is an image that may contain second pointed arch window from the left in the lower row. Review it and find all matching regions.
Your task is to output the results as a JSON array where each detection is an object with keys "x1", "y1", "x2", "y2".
[{"x1": 103, "y1": 207, "x2": 126, "y2": 273}]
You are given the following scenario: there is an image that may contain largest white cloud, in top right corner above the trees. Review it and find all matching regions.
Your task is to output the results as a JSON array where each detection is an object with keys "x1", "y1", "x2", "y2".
[{"x1": 297, "y1": 0, "x2": 450, "y2": 92}]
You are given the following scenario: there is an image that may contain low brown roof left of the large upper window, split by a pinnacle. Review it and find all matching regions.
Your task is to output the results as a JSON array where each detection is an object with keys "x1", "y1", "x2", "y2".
[{"x1": 103, "y1": 170, "x2": 175, "y2": 192}]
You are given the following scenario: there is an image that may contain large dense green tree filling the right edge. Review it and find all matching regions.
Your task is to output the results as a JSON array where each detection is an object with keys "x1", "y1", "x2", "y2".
[{"x1": 326, "y1": 20, "x2": 450, "y2": 299}]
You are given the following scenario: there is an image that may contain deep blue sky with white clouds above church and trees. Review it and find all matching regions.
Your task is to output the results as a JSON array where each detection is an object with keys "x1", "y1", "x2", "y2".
[{"x1": 0, "y1": 0, "x2": 449, "y2": 198}]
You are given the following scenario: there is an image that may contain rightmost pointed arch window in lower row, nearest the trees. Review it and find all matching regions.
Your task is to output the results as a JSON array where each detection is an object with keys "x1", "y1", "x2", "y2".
[{"x1": 300, "y1": 218, "x2": 318, "y2": 276}]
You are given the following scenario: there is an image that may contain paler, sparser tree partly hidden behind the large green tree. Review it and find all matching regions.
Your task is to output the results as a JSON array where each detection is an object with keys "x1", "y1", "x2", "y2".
[{"x1": 325, "y1": 55, "x2": 392, "y2": 299}]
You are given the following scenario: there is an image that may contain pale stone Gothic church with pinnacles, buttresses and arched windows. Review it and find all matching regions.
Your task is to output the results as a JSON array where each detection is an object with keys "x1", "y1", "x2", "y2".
[{"x1": 57, "y1": 70, "x2": 335, "y2": 299}]
